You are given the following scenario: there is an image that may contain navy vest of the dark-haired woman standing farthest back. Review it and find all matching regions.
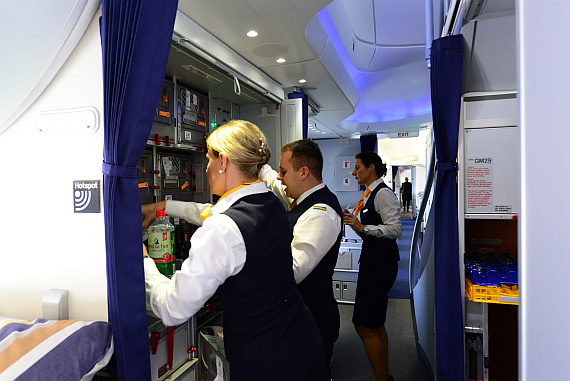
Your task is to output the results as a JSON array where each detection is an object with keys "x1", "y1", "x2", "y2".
[{"x1": 360, "y1": 183, "x2": 400, "y2": 264}]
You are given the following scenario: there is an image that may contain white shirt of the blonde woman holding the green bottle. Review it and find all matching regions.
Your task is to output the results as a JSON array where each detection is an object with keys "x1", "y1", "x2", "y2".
[{"x1": 144, "y1": 183, "x2": 268, "y2": 325}]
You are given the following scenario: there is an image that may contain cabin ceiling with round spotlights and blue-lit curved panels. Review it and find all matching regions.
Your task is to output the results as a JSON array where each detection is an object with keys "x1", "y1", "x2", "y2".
[{"x1": 178, "y1": 0, "x2": 431, "y2": 138}]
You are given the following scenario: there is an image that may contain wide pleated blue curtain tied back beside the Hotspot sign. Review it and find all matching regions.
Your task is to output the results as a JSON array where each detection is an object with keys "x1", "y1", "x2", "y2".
[{"x1": 100, "y1": 0, "x2": 178, "y2": 380}]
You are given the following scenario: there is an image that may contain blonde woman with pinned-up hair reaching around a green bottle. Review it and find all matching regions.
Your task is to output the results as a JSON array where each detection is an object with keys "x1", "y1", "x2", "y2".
[{"x1": 143, "y1": 120, "x2": 327, "y2": 381}]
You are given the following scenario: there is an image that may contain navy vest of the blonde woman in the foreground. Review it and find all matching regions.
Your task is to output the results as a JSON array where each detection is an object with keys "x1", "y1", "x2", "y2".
[{"x1": 218, "y1": 192, "x2": 320, "y2": 377}]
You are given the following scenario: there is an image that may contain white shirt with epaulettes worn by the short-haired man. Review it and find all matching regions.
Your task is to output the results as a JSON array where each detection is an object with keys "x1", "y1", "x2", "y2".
[{"x1": 259, "y1": 165, "x2": 342, "y2": 284}]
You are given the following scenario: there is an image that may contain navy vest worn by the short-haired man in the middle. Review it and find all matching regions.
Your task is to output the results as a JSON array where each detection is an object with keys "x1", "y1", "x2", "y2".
[{"x1": 287, "y1": 186, "x2": 342, "y2": 308}]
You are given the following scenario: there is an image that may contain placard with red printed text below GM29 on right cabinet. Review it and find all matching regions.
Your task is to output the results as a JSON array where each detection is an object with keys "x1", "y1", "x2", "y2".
[{"x1": 465, "y1": 157, "x2": 493, "y2": 212}]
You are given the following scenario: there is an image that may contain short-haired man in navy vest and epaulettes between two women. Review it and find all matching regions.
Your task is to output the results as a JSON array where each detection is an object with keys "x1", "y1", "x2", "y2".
[{"x1": 259, "y1": 140, "x2": 342, "y2": 378}]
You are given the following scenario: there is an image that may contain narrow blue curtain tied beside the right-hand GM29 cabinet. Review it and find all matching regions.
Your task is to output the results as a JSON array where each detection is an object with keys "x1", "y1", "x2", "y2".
[{"x1": 430, "y1": 35, "x2": 465, "y2": 381}]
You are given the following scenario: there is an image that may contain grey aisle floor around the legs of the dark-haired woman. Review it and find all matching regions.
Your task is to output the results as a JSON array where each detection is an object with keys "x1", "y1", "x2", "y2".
[{"x1": 332, "y1": 299, "x2": 432, "y2": 381}]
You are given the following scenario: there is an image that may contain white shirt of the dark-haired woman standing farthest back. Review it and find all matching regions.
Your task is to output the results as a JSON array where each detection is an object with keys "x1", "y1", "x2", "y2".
[{"x1": 360, "y1": 178, "x2": 402, "y2": 238}]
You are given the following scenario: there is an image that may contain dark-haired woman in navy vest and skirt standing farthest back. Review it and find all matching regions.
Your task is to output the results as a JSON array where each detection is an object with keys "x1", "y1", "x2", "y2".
[{"x1": 343, "y1": 152, "x2": 402, "y2": 381}]
